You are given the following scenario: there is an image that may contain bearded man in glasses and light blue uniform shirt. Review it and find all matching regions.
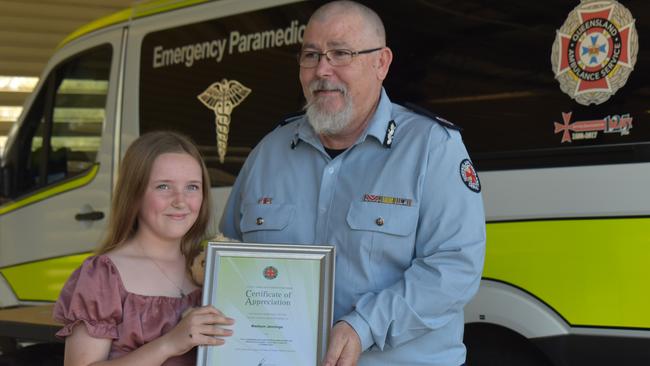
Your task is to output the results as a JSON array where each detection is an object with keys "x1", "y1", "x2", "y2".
[{"x1": 221, "y1": 1, "x2": 485, "y2": 366}]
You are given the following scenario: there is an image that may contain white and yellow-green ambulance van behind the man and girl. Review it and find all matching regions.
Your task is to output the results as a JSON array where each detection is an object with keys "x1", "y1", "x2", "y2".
[{"x1": 0, "y1": 0, "x2": 650, "y2": 366}]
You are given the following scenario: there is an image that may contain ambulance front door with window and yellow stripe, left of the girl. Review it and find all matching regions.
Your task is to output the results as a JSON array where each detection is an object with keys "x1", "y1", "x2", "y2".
[{"x1": 0, "y1": 29, "x2": 123, "y2": 306}]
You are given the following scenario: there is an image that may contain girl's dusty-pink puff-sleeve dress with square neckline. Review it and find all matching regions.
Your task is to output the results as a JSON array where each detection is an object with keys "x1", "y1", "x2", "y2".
[{"x1": 54, "y1": 255, "x2": 201, "y2": 366}]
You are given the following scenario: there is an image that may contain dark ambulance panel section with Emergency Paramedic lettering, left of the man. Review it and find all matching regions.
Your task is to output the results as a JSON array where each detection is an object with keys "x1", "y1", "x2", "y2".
[{"x1": 139, "y1": 2, "x2": 316, "y2": 187}]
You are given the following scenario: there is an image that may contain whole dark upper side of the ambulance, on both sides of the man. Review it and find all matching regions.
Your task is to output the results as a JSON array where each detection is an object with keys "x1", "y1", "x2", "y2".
[{"x1": 139, "y1": 0, "x2": 650, "y2": 174}]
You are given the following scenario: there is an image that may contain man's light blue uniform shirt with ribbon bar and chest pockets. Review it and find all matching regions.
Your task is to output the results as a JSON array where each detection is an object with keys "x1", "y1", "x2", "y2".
[{"x1": 220, "y1": 90, "x2": 485, "y2": 366}]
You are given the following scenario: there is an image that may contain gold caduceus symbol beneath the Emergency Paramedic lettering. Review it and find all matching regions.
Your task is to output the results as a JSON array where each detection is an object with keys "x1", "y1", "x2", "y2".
[{"x1": 197, "y1": 79, "x2": 251, "y2": 164}]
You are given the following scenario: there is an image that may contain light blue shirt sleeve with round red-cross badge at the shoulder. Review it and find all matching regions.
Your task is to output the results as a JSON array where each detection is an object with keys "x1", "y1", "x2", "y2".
[{"x1": 340, "y1": 131, "x2": 485, "y2": 350}]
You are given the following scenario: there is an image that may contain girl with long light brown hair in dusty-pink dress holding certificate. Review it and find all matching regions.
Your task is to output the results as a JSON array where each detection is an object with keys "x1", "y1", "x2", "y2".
[{"x1": 54, "y1": 132, "x2": 233, "y2": 366}]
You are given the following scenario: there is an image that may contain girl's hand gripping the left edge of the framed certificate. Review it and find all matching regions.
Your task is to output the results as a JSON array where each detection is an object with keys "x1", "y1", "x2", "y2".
[{"x1": 162, "y1": 305, "x2": 235, "y2": 356}]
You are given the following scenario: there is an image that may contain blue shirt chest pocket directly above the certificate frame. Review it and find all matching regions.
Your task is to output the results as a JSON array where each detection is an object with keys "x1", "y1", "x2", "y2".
[{"x1": 239, "y1": 203, "x2": 295, "y2": 243}]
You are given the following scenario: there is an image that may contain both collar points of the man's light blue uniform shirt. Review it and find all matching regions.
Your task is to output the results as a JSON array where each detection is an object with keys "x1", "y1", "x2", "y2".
[{"x1": 293, "y1": 87, "x2": 393, "y2": 149}]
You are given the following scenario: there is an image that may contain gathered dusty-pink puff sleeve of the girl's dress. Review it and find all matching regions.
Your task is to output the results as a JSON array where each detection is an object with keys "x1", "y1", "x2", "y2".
[{"x1": 54, "y1": 256, "x2": 123, "y2": 339}]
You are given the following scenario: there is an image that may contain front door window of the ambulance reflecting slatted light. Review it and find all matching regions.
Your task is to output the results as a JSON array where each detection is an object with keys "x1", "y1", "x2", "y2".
[{"x1": 9, "y1": 45, "x2": 112, "y2": 196}]
